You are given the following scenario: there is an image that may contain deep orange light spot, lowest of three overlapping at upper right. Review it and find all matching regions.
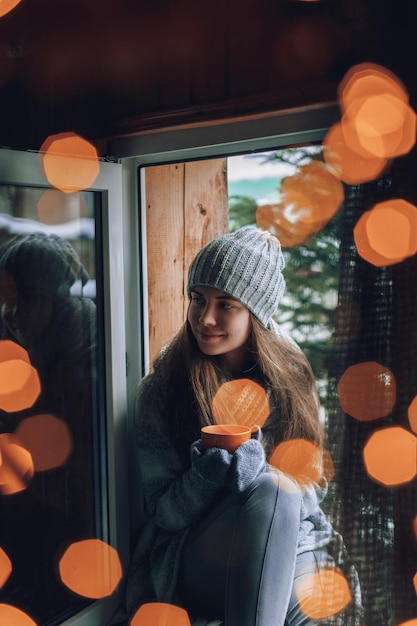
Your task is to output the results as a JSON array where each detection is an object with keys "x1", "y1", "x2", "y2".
[{"x1": 323, "y1": 123, "x2": 388, "y2": 185}]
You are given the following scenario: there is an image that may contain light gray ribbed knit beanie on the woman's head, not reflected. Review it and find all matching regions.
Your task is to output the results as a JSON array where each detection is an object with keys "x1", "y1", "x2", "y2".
[{"x1": 187, "y1": 226, "x2": 285, "y2": 326}]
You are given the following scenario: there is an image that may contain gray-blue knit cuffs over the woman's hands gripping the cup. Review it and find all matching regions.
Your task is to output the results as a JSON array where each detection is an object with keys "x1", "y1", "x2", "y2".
[{"x1": 190, "y1": 439, "x2": 267, "y2": 493}]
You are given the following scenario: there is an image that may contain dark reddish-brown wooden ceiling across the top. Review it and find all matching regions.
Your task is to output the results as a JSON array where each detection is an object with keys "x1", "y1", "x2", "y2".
[{"x1": 0, "y1": 0, "x2": 416, "y2": 150}]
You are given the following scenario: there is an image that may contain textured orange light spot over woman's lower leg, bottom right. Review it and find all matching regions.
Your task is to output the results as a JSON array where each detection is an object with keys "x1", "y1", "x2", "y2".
[{"x1": 297, "y1": 568, "x2": 351, "y2": 619}]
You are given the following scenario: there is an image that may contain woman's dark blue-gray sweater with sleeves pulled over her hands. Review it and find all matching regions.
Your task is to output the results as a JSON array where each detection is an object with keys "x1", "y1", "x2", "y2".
[{"x1": 126, "y1": 352, "x2": 360, "y2": 615}]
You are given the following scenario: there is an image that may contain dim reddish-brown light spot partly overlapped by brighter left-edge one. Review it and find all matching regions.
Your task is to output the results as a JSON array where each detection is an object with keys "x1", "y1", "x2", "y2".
[{"x1": 15, "y1": 414, "x2": 72, "y2": 472}]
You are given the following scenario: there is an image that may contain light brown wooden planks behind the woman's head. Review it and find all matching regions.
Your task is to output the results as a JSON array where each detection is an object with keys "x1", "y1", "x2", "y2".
[{"x1": 145, "y1": 159, "x2": 228, "y2": 363}]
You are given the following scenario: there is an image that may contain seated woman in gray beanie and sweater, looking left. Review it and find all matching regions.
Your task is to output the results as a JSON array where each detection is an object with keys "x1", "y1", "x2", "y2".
[{"x1": 127, "y1": 227, "x2": 361, "y2": 626}]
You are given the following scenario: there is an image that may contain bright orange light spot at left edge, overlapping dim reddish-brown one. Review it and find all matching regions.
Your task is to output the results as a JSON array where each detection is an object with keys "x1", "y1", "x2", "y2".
[{"x1": 0, "y1": 433, "x2": 34, "y2": 495}]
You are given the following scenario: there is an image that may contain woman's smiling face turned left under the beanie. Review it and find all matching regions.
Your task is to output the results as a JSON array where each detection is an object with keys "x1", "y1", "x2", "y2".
[{"x1": 188, "y1": 286, "x2": 252, "y2": 372}]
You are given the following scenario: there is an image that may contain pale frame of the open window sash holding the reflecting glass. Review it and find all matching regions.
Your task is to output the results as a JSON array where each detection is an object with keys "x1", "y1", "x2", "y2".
[{"x1": 0, "y1": 149, "x2": 129, "y2": 626}]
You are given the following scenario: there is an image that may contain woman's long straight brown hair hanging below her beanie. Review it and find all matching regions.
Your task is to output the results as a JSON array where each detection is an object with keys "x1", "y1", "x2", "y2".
[{"x1": 155, "y1": 314, "x2": 324, "y2": 455}]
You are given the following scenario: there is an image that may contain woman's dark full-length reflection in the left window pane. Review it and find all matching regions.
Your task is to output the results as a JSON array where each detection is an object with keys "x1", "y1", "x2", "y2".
[{"x1": 0, "y1": 233, "x2": 96, "y2": 623}]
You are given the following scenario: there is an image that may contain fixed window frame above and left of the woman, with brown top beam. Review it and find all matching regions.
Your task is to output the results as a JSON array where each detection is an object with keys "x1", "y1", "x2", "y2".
[{"x1": 115, "y1": 101, "x2": 340, "y2": 378}]
